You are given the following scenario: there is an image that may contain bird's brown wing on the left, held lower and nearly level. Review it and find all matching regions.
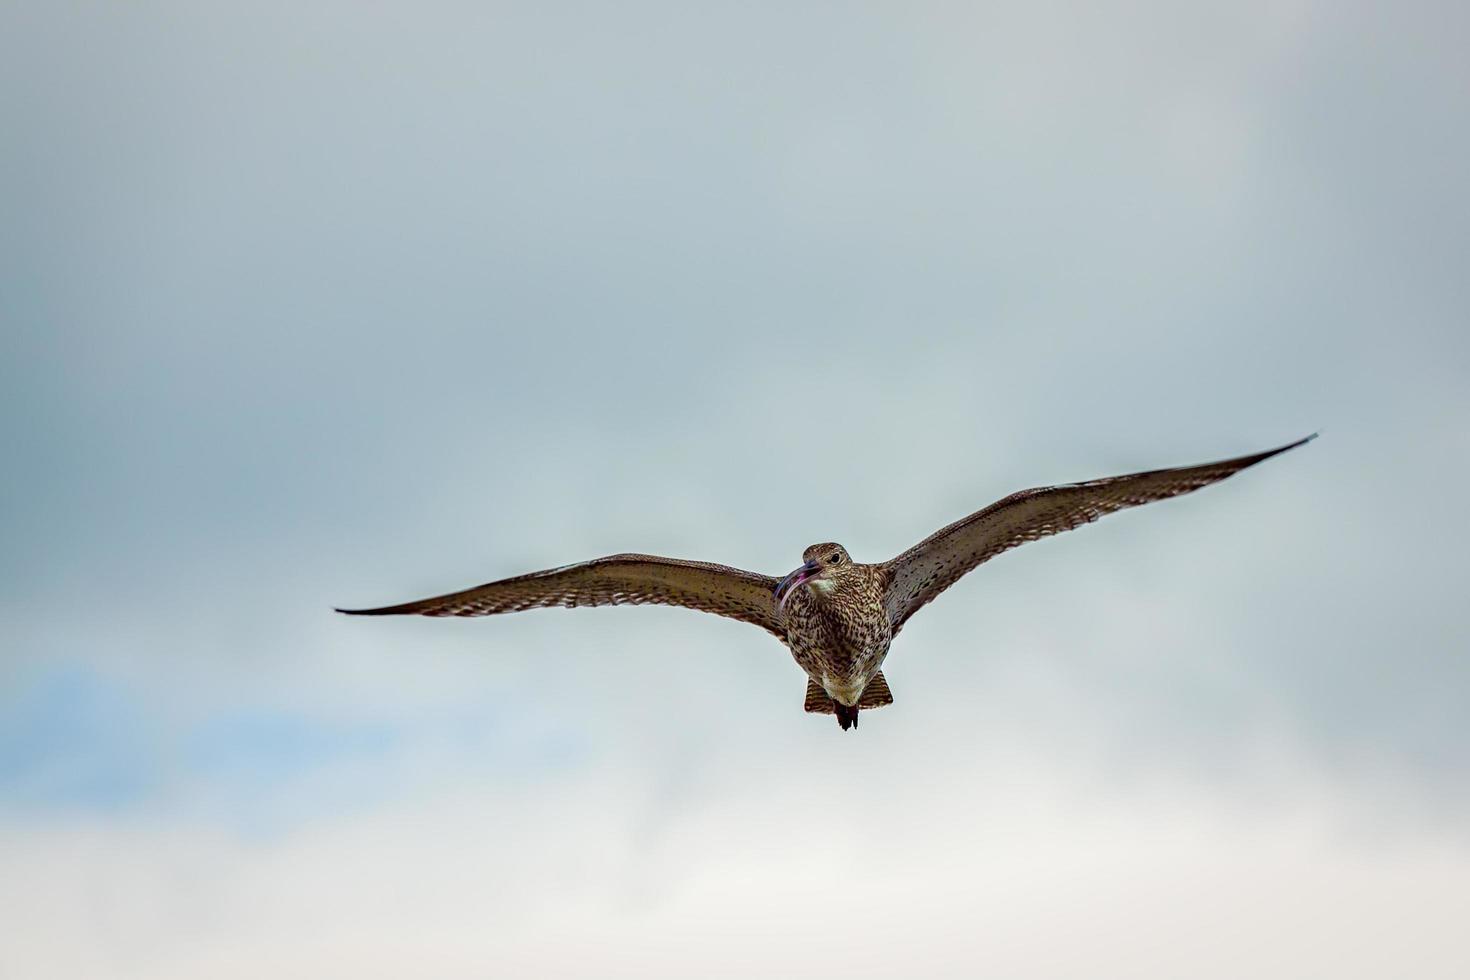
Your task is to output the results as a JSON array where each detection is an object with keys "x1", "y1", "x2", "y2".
[{"x1": 337, "y1": 555, "x2": 785, "y2": 639}]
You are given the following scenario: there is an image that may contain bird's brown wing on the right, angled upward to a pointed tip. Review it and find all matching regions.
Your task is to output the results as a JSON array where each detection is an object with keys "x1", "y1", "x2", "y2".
[{"x1": 883, "y1": 435, "x2": 1317, "y2": 633}]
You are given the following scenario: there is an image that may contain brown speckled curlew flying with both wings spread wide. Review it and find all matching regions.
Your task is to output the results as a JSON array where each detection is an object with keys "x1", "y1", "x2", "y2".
[{"x1": 337, "y1": 433, "x2": 1317, "y2": 732}]
